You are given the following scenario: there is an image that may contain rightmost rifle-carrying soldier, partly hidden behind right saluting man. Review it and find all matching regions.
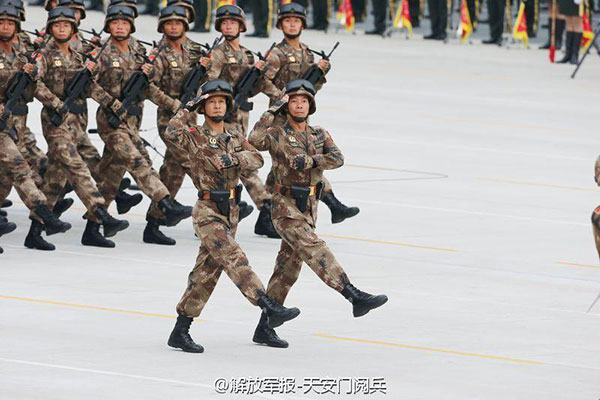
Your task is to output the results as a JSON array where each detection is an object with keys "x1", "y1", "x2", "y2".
[{"x1": 265, "y1": 3, "x2": 360, "y2": 224}]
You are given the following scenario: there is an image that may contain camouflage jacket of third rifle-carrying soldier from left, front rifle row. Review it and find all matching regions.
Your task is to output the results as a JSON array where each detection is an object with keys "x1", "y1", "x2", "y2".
[{"x1": 95, "y1": 38, "x2": 179, "y2": 111}]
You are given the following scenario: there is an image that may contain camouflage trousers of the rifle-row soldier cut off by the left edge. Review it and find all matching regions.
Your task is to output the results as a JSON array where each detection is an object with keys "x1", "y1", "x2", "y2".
[{"x1": 0, "y1": 132, "x2": 46, "y2": 210}]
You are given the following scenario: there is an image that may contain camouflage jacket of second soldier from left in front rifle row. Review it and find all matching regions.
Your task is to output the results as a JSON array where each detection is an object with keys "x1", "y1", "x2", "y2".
[{"x1": 35, "y1": 39, "x2": 114, "y2": 110}]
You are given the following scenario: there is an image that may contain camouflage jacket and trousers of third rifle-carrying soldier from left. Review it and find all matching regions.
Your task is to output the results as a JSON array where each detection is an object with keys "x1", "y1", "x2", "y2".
[{"x1": 96, "y1": 39, "x2": 179, "y2": 211}]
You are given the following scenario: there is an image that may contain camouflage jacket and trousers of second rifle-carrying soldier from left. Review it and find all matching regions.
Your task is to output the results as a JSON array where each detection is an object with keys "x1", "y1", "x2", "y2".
[{"x1": 36, "y1": 39, "x2": 113, "y2": 220}]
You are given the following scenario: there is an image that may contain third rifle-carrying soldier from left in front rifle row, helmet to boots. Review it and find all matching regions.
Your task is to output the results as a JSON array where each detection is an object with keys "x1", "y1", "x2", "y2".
[{"x1": 92, "y1": 6, "x2": 190, "y2": 238}]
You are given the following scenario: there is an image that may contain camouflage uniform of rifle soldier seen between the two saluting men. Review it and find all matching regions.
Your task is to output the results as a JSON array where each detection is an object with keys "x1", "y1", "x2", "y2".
[{"x1": 208, "y1": 41, "x2": 281, "y2": 209}]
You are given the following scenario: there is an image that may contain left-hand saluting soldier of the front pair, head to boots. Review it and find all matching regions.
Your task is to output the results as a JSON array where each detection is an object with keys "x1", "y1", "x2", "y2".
[{"x1": 166, "y1": 80, "x2": 300, "y2": 353}]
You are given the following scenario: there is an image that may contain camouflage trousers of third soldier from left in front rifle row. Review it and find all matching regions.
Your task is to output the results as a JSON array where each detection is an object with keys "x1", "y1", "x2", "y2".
[{"x1": 96, "y1": 108, "x2": 169, "y2": 207}]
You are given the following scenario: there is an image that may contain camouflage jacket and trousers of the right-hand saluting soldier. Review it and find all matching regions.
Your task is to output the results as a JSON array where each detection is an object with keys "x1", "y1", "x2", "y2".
[{"x1": 249, "y1": 112, "x2": 349, "y2": 304}]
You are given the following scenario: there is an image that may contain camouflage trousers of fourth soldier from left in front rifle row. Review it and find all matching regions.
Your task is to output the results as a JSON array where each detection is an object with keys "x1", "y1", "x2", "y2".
[{"x1": 146, "y1": 122, "x2": 191, "y2": 219}]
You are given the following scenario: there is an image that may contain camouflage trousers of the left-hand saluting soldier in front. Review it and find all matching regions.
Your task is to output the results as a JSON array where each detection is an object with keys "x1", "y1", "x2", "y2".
[{"x1": 177, "y1": 205, "x2": 265, "y2": 318}]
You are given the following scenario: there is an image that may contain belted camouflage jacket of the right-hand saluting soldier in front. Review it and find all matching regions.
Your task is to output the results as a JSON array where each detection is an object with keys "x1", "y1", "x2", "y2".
[{"x1": 249, "y1": 111, "x2": 344, "y2": 226}]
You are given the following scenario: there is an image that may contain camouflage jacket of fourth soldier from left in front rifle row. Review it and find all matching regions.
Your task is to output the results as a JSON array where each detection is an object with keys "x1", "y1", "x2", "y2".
[{"x1": 153, "y1": 38, "x2": 203, "y2": 126}]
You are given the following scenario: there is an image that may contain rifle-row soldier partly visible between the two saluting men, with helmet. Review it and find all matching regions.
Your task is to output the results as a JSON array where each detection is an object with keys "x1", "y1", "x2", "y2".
[{"x1": 201, "y1": 5, "x2": 281, "y2": 238}]
